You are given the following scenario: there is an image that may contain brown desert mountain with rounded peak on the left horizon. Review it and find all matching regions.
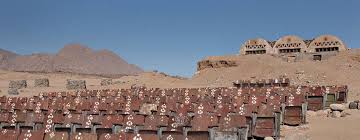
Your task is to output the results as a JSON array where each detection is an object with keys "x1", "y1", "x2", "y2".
[{"x1": 0, "y1": 44, "x2": 143, "y2": 75}]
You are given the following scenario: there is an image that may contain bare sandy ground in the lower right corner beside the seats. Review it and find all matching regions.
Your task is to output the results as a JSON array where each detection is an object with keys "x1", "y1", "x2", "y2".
[{"x1": 280, "y1": 110, "x2": 360, "y2": 140}]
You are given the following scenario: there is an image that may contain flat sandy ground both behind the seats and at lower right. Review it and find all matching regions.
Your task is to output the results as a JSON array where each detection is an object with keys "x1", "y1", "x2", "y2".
[{"x1": 0, "y1": 71, "x2": 360, "y2": 140}]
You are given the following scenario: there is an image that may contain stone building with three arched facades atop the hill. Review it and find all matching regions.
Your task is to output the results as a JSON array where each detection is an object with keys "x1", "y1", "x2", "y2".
[{"x1": 240, "y1": 35, "x2": 348, "y2": 61}]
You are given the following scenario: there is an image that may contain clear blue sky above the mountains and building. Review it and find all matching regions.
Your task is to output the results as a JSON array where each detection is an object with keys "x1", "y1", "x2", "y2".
[{"x1": 0, "y1": 0, "x2": 360, "y2": 77}]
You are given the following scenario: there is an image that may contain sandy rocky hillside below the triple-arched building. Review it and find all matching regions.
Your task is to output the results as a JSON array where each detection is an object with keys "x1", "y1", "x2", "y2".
[{"x1": 191, "y1": 49, "x2": 360, "y2": 99}]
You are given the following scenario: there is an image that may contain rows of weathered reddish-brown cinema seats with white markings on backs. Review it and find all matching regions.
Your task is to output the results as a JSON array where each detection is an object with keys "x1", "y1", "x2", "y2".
[{"x1": 0, "y1": 86, "x2": 348, "y2": 140}]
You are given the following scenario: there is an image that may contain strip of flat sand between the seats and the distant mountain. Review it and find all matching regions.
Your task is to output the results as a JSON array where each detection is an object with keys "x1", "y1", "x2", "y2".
[{"x1": 0, "y1": 70, "x2": 197, "y2": 97}]
